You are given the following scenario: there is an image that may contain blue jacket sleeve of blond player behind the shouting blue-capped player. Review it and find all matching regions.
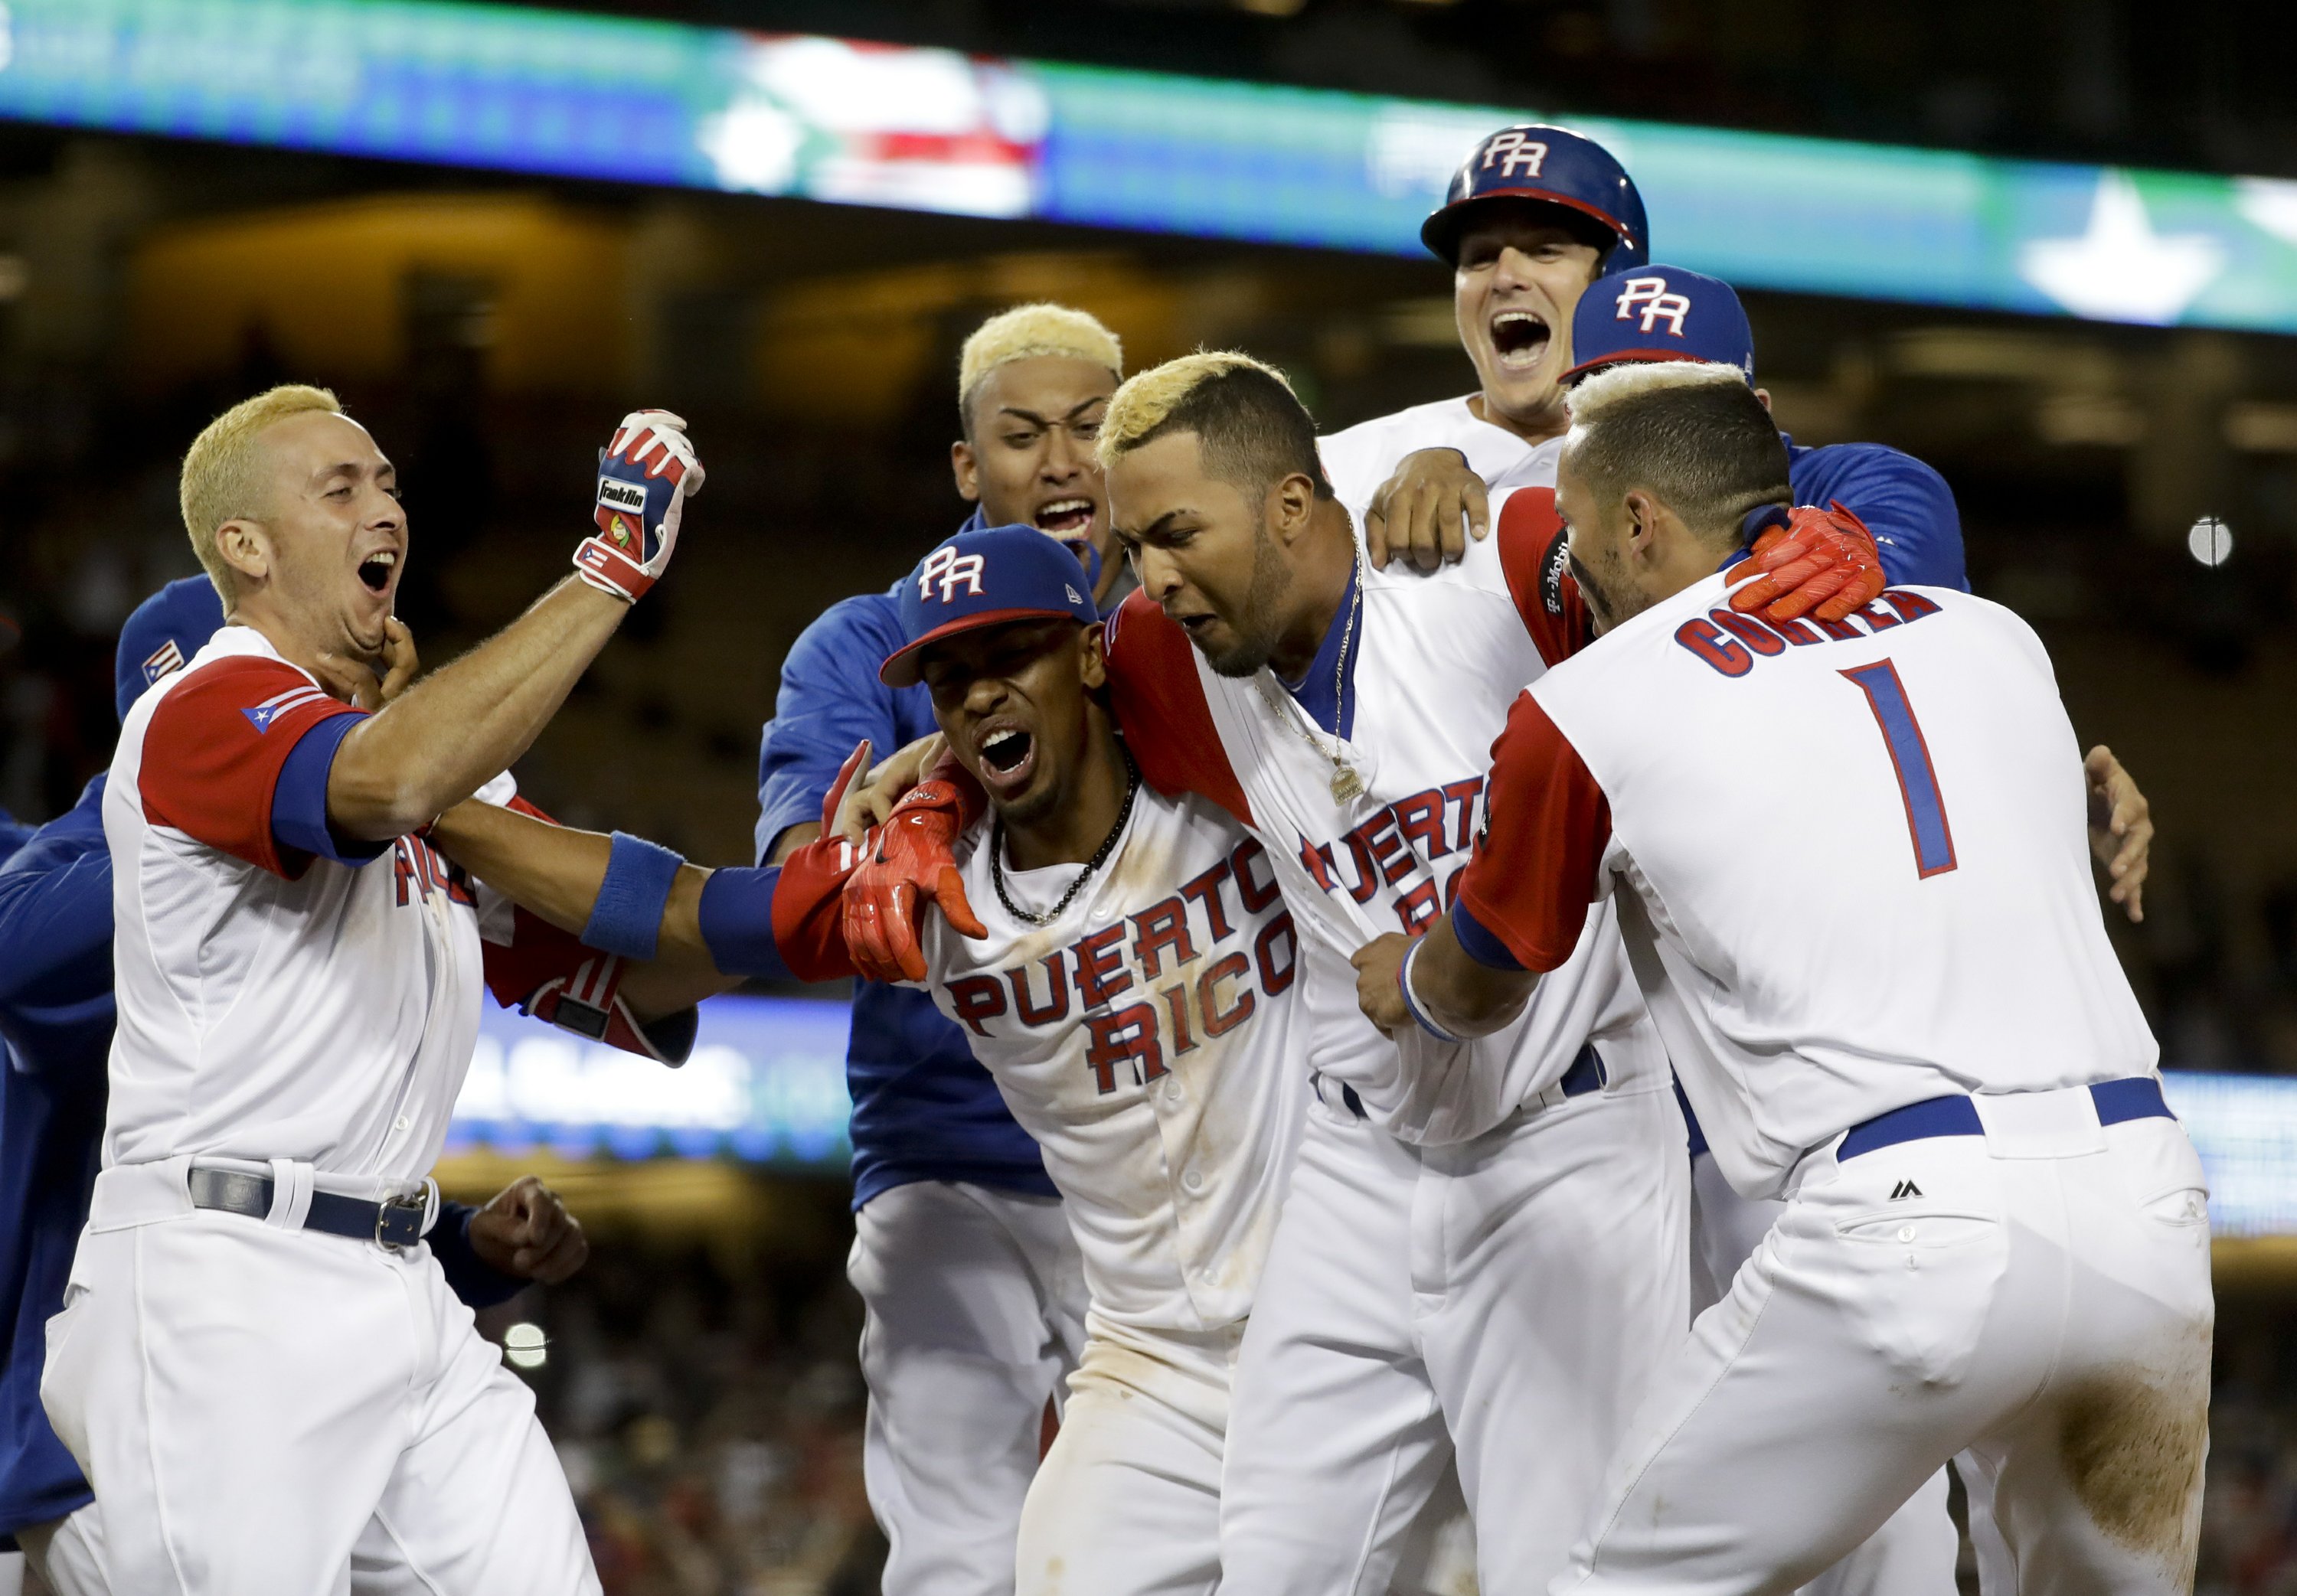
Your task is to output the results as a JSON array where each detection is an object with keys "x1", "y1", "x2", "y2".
[{"x1": 758, "y1": 592, "x2": 907, "y2": 863}]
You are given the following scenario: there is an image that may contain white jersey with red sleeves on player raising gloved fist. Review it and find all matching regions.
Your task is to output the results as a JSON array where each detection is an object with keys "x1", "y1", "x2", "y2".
[{"x1": 103, "y1": 625, "x2": 648, "y2": 1192}]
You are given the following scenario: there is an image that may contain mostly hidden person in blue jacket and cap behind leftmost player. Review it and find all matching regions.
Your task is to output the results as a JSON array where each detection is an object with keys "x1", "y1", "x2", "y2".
[{"x1": 0, "y1": 576, "x2": 590, "y2": 1596}]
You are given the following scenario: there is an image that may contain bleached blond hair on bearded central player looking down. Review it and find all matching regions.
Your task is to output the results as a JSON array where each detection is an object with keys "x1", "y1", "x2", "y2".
[{"x1": 1093, "y1": 349, "x2": 1332, "y2": 498}]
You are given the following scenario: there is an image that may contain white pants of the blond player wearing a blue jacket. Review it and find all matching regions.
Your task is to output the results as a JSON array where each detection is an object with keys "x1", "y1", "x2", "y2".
[{"x1": 845, "y1": 1180, "x2": 1084, "y2": 1596}]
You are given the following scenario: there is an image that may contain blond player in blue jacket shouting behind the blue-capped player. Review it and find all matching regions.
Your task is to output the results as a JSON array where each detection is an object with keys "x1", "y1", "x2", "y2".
[{"x1": 756, "y1": 305, "x2": 1123, "y2": 1596}]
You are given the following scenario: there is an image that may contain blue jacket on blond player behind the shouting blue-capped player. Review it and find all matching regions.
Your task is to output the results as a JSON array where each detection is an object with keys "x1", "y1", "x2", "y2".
[{"x1": 758, "y1": 583, "x2": 1057, "y2": 1208}]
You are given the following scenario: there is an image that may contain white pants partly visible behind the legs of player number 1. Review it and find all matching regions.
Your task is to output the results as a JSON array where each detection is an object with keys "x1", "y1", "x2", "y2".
[{"x1": 1691, "y1": 1155, "x2": 1962, "y2": 1596}]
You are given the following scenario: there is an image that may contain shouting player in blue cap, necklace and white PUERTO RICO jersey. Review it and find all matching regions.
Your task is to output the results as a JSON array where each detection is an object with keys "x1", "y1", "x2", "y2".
[{"x1": 416, "y1": 526, "x2": 1307, "y2": 1596}]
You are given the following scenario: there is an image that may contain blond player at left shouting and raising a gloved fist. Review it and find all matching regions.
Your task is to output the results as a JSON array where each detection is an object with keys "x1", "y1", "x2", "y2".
[{"x1": 41, "y1": 388, "x2": 701, "y2": 1594}]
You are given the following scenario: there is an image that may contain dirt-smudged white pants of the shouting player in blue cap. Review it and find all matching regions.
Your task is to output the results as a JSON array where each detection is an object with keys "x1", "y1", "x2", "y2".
[{"x1": 1018, "y1": 1314, "x2": 1245, "y2": 1596}]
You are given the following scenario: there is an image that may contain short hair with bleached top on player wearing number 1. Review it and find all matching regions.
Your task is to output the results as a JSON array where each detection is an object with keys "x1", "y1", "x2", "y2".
[{"x1": 1571, "y1": 361, "x2": 1794, "y2": 542}]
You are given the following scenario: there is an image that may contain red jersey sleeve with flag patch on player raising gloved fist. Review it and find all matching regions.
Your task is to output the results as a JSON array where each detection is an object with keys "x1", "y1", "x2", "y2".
[{"x1": 136, "y1": 654, "x2": 365, "y2": 880}]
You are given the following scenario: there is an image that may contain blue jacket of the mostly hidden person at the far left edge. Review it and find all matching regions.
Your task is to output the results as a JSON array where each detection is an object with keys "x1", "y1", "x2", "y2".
[{"x1": 0, "y1": 776, "x2": 526, "y2": 1545}]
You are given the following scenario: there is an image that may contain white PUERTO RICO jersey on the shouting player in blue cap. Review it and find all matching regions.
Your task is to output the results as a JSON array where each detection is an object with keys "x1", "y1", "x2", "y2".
[{"x1": 774, "y1": 783, "x2": 1307, "y2": 1332}]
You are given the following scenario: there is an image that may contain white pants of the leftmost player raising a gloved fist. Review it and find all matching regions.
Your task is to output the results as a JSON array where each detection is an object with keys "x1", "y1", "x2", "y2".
[{"x1": 39, "y1": 1157, "x2": 597, "y2": 1596}]
